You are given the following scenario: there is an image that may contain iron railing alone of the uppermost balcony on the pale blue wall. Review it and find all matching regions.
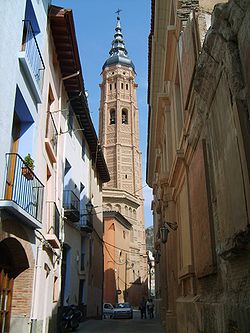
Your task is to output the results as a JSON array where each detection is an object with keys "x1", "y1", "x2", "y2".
[{"x1": 22, "y1": 20, "x2": 45, "y2": 89}]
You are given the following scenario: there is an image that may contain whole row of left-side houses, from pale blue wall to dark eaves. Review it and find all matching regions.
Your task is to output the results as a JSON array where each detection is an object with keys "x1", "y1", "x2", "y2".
[{"x1": 0, "y1": 0, "x2": 109, "y2": 333}]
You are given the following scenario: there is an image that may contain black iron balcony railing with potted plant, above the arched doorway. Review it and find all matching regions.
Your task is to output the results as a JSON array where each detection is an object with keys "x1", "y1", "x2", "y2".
[{"x1": 3, "y1": 153, "x2": 44, "y2": 222}]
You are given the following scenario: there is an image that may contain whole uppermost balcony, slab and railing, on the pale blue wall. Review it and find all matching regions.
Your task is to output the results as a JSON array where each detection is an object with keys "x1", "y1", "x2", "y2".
[{"x1": 19, "y1": 20, "x2": 45, "y2": 103}]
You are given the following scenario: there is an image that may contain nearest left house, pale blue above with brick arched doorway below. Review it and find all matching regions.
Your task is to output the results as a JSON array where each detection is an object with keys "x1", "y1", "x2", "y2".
[{"x1": 0, "y1": 0, "x2": 58, "y2": 332}]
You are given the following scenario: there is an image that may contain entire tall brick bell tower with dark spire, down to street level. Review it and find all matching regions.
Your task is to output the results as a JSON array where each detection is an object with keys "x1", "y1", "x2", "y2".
[{"x1": 99, "y1": 16, "x2": 147, "y2": 304}]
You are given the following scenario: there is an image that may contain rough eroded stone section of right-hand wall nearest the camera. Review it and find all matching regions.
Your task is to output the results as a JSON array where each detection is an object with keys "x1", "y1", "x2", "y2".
[{"x1": 177, "y1": 0, "x2": 250, "y2": 333}]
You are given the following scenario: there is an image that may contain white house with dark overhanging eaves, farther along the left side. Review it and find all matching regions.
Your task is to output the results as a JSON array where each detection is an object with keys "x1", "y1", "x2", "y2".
[{"x1": 49, "y1": 6, "x2": 110, "y2": 317}]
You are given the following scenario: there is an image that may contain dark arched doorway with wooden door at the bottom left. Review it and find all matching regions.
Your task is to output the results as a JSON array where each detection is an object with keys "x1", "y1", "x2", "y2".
[{"x1": 0, "y1": 237, "x2": 29, "y2": 333}]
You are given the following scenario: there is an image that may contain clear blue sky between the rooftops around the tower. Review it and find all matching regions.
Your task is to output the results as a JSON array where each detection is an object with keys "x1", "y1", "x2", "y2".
[{"x1": 52, "y1": 0, "x2": 152, "y2": 227}]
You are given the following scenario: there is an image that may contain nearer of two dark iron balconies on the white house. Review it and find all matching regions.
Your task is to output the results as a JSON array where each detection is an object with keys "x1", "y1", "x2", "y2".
[{"x1": 63, "y1": 190, "x2": 80, "y2": 222}]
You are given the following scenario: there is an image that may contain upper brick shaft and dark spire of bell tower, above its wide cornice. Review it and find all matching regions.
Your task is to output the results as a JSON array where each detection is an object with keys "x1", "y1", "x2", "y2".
[{"x1": 99, "y1": 16, "x2": 142, "y2": 196}]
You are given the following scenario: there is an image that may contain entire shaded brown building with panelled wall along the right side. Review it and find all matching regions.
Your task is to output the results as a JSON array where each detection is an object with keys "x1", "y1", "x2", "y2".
[{"x1": 147, "y1": 0, "x2": 250, "y2": 332}]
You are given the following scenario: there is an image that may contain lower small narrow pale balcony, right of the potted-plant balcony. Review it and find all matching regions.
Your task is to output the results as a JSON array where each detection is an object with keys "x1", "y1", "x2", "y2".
[{"x1": 45, "y1": 201, "x2": 60, "y2": 249}]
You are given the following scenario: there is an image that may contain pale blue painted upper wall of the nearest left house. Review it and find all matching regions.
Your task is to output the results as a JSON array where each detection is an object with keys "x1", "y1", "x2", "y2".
[{"x1": 0, "y1": 0, "x2": 48, "y2": 188}]
